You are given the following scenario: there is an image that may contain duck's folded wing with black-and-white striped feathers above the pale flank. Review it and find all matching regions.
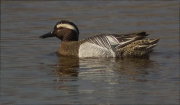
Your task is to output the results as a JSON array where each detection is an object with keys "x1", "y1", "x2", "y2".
[{"x1": 82, "y1": 32, "x2": 148, "y2": 49}]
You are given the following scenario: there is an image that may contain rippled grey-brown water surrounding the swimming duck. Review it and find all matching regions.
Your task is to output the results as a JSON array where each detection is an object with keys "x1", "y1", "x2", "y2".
[{"x1": 0, "y1": 1, "x2": 179, "y2": 104}]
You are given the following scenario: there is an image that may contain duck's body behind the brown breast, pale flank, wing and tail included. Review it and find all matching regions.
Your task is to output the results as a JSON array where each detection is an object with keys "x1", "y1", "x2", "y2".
[{"x1": 79, "y1": 32, "x2": 159, "y2": 57}]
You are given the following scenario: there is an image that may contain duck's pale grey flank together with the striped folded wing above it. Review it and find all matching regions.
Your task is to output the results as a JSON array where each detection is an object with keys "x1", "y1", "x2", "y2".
[{"x1": 79, "y1": 32, "x2": 147, "y2": 57}]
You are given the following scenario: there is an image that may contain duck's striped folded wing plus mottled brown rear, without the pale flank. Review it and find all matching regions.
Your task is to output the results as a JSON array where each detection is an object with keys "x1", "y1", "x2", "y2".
[{"x1": 80, "y1": 32, "x2": 159, "y2": 57}]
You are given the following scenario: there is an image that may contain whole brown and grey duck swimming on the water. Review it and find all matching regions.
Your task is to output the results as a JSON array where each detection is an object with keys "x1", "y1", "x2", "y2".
[{"x1": 39, "y1": 20, "x2": 159, "y2": 58}]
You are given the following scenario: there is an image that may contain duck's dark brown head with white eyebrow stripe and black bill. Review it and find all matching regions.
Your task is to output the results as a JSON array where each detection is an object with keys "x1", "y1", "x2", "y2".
[{"x1": 39, "y1": 20, "x2": 79, "y2": 41}]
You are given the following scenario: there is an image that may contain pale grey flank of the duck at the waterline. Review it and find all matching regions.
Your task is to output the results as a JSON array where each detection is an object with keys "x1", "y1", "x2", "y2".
[{"x1": 79, "y1": 43, "x2": 116, "y2": 57}]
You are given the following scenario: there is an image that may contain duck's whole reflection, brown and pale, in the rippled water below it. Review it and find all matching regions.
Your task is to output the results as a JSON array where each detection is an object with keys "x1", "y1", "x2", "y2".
[{"x1": 50, "y1": 56, "x2": 157, "y2": 100}]
